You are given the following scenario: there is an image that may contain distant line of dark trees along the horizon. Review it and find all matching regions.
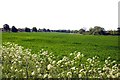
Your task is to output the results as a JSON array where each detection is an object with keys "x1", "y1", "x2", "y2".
[{"x1": 2, "y1": 24, "x2": 120, "y2": 35}]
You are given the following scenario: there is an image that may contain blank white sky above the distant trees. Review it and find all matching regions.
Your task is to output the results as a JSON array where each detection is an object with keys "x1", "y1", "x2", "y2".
[{"x1": 0, "y1": 0, "x2": 119, "y2": 30}]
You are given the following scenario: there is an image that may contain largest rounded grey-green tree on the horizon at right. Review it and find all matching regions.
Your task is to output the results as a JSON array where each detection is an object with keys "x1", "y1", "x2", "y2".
[{"x1": 89, "y1": 26, "x2": 106, "y2": 35}]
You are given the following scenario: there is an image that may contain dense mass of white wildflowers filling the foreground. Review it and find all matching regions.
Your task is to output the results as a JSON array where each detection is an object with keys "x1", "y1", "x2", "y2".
[{"x1": 0, "y1": 42, "x2": 120, "y2": 78}]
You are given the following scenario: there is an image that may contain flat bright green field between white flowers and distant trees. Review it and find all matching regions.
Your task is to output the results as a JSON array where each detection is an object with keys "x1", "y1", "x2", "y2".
[{"x1": 2, "y1": 32, "x2": 120, "y2": 63}]
